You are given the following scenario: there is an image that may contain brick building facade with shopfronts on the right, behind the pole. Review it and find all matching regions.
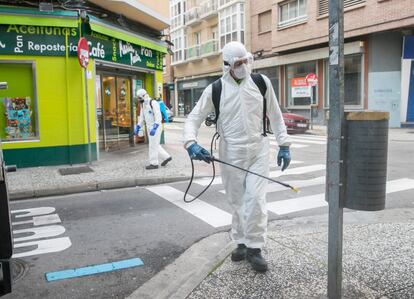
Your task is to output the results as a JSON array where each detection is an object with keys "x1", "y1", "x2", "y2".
[{"x1": 246, "y1": 0, "x2": 414, "y2": 127}]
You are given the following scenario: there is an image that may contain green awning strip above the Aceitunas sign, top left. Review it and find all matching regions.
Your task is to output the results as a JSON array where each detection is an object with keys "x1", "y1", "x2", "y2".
[{"x1": 0, "y1": 6, "x2": 79, "y2": 27}]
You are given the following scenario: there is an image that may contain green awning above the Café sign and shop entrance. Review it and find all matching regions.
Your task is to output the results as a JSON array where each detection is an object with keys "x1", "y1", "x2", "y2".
[{"x1": 89, "y1": 16, "x2": 167, "y2": 53}]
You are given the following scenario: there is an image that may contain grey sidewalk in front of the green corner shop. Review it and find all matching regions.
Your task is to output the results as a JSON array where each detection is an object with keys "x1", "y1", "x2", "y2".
[{"x1": 8, "y1": 136, "x2": 217, "y2": 200}]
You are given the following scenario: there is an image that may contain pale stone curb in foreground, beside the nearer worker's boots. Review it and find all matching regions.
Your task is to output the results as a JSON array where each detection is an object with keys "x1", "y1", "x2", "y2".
[{"x1": 127, "y1": 232, "x2": 234, "y2": 299}]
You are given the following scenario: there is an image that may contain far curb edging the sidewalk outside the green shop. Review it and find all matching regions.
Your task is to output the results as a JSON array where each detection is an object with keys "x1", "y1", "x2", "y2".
[{"x1": 9, "y1": 176, "x2": 197, "y2": 200}]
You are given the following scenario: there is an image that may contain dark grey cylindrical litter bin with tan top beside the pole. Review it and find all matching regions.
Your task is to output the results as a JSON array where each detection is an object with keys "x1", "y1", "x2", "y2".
[{"x1": 344, "y1": 112, "x2": 389, "y2": 211}]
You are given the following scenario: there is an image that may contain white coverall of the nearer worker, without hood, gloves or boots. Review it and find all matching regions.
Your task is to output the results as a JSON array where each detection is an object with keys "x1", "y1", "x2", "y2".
[{"x1": 184, "y1": 44, "x2": 290, "y2": 249}]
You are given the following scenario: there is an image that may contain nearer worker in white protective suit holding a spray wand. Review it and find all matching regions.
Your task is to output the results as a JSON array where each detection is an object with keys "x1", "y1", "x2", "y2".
[{"x1": 184, "y1": 42, "x2": 291, "y2": 272}]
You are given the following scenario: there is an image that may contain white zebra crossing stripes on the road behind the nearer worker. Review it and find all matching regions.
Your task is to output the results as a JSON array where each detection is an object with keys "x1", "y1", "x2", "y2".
[{"x1": 142, "y1": 134, "x2": 414, "y2": 228}]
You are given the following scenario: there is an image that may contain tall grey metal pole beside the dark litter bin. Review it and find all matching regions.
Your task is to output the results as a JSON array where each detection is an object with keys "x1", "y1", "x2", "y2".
[{"x1": 326, "y1": 0, "x2": 344, "y2": 299}]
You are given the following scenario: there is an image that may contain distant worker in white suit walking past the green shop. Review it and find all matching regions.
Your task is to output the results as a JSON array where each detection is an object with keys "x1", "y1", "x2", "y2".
[{"x1": 134, "y1": 89, "x2": 172, "y2": 169}]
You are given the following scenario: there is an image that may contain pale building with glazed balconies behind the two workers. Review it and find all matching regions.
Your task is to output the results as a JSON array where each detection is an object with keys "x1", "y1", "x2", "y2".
[{"x1": 170, "y1": 0, "x2": 245, "y2": 116}]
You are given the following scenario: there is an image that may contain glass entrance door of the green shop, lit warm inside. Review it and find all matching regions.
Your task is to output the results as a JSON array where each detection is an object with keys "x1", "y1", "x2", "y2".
[{"x1": 98, "y1": 75, "x2": 132, "y2": 151}]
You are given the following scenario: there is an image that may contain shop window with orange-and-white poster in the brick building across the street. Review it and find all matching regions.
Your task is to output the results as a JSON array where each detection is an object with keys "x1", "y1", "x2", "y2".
[{"x1": 285, "y1": 61, "x2": 318, "y2": 108}]
